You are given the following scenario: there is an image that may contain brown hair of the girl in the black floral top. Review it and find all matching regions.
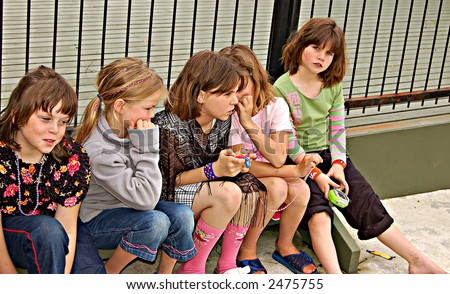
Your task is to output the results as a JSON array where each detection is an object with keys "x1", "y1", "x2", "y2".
[{"x1": 0, "y1": 65, "x2": 78, "y2": 160}]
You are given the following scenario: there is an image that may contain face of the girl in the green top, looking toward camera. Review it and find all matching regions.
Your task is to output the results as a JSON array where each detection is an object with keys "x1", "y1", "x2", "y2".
[{"x1": 301, "y1": 44, "x2": 334, "y2": 74}]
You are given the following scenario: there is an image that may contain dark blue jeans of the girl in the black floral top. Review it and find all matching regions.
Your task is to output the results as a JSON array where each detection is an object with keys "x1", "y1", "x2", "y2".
[{"x1": 2, "y1": 215, "x2": 106, "y2": 274}]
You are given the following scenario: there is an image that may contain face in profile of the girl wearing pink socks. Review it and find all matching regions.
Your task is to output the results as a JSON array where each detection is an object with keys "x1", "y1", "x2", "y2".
[{"x1": 197, "y1": 86, "x2": 239, "y2": 121}]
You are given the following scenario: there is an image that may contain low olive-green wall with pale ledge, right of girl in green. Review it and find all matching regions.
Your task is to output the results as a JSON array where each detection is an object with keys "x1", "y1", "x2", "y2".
[{"x1": 347, "y1": 115, "x2": 450, "y2": 198}]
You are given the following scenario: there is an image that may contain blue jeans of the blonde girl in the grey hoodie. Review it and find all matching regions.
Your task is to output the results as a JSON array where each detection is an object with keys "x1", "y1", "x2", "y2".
[{"x1": 86, "y1": 201, "x2": 197, "y2": 262}]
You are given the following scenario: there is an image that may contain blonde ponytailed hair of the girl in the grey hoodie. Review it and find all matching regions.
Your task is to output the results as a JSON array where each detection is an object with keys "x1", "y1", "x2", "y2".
[{"x1": 74, "y1": 57, "x2": 167, "y2": 144}]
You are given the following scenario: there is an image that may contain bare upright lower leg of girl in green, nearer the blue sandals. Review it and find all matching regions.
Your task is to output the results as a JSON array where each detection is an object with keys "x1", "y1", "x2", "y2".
[{"x1": 308, "y1": 212, "x2": 342, "y2": 274}]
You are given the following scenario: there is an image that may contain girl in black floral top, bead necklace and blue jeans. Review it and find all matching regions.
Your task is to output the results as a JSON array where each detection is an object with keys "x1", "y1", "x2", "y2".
[{"x1": 0, "y1": 66, "x2": 105, "y2": 274}]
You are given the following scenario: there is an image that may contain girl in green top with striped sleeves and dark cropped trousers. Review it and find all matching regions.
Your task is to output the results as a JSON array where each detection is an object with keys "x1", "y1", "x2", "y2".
[{"x1": 274, "y1": 18, "x2": 445, "y2": 273}]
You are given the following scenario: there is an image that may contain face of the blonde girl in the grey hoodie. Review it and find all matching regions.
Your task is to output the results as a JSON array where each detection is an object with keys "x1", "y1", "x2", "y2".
[{"x1": 122, "y1": 90, "x2": 162, "y2": 128}]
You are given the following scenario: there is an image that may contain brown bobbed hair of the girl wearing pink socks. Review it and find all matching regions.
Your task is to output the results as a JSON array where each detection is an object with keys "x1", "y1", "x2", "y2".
[{"x1": 164, "y1": 50, "x2": 244, "y2": 120}]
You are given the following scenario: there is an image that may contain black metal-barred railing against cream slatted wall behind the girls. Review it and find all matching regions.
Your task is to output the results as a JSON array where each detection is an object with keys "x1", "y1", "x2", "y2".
[{"x1": 0, "y1": 0, "x2": 450, "y2": 123}]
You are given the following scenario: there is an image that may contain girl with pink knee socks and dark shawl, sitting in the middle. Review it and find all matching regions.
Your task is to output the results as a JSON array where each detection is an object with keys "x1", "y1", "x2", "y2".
[{"x1": 154, "y1": 51, "x2": 265, "y2": 274}]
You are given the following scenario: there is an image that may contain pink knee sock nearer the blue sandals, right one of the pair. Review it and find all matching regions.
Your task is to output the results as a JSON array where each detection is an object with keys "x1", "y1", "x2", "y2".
[{"x1": 217, "y1": 223, "x2": 248, "y2": 274}]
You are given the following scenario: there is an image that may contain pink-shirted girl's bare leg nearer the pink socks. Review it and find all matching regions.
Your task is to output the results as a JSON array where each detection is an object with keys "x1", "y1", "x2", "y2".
[{"x1": 237, "y1": 177, "x2": 287, "y2": 274}]
